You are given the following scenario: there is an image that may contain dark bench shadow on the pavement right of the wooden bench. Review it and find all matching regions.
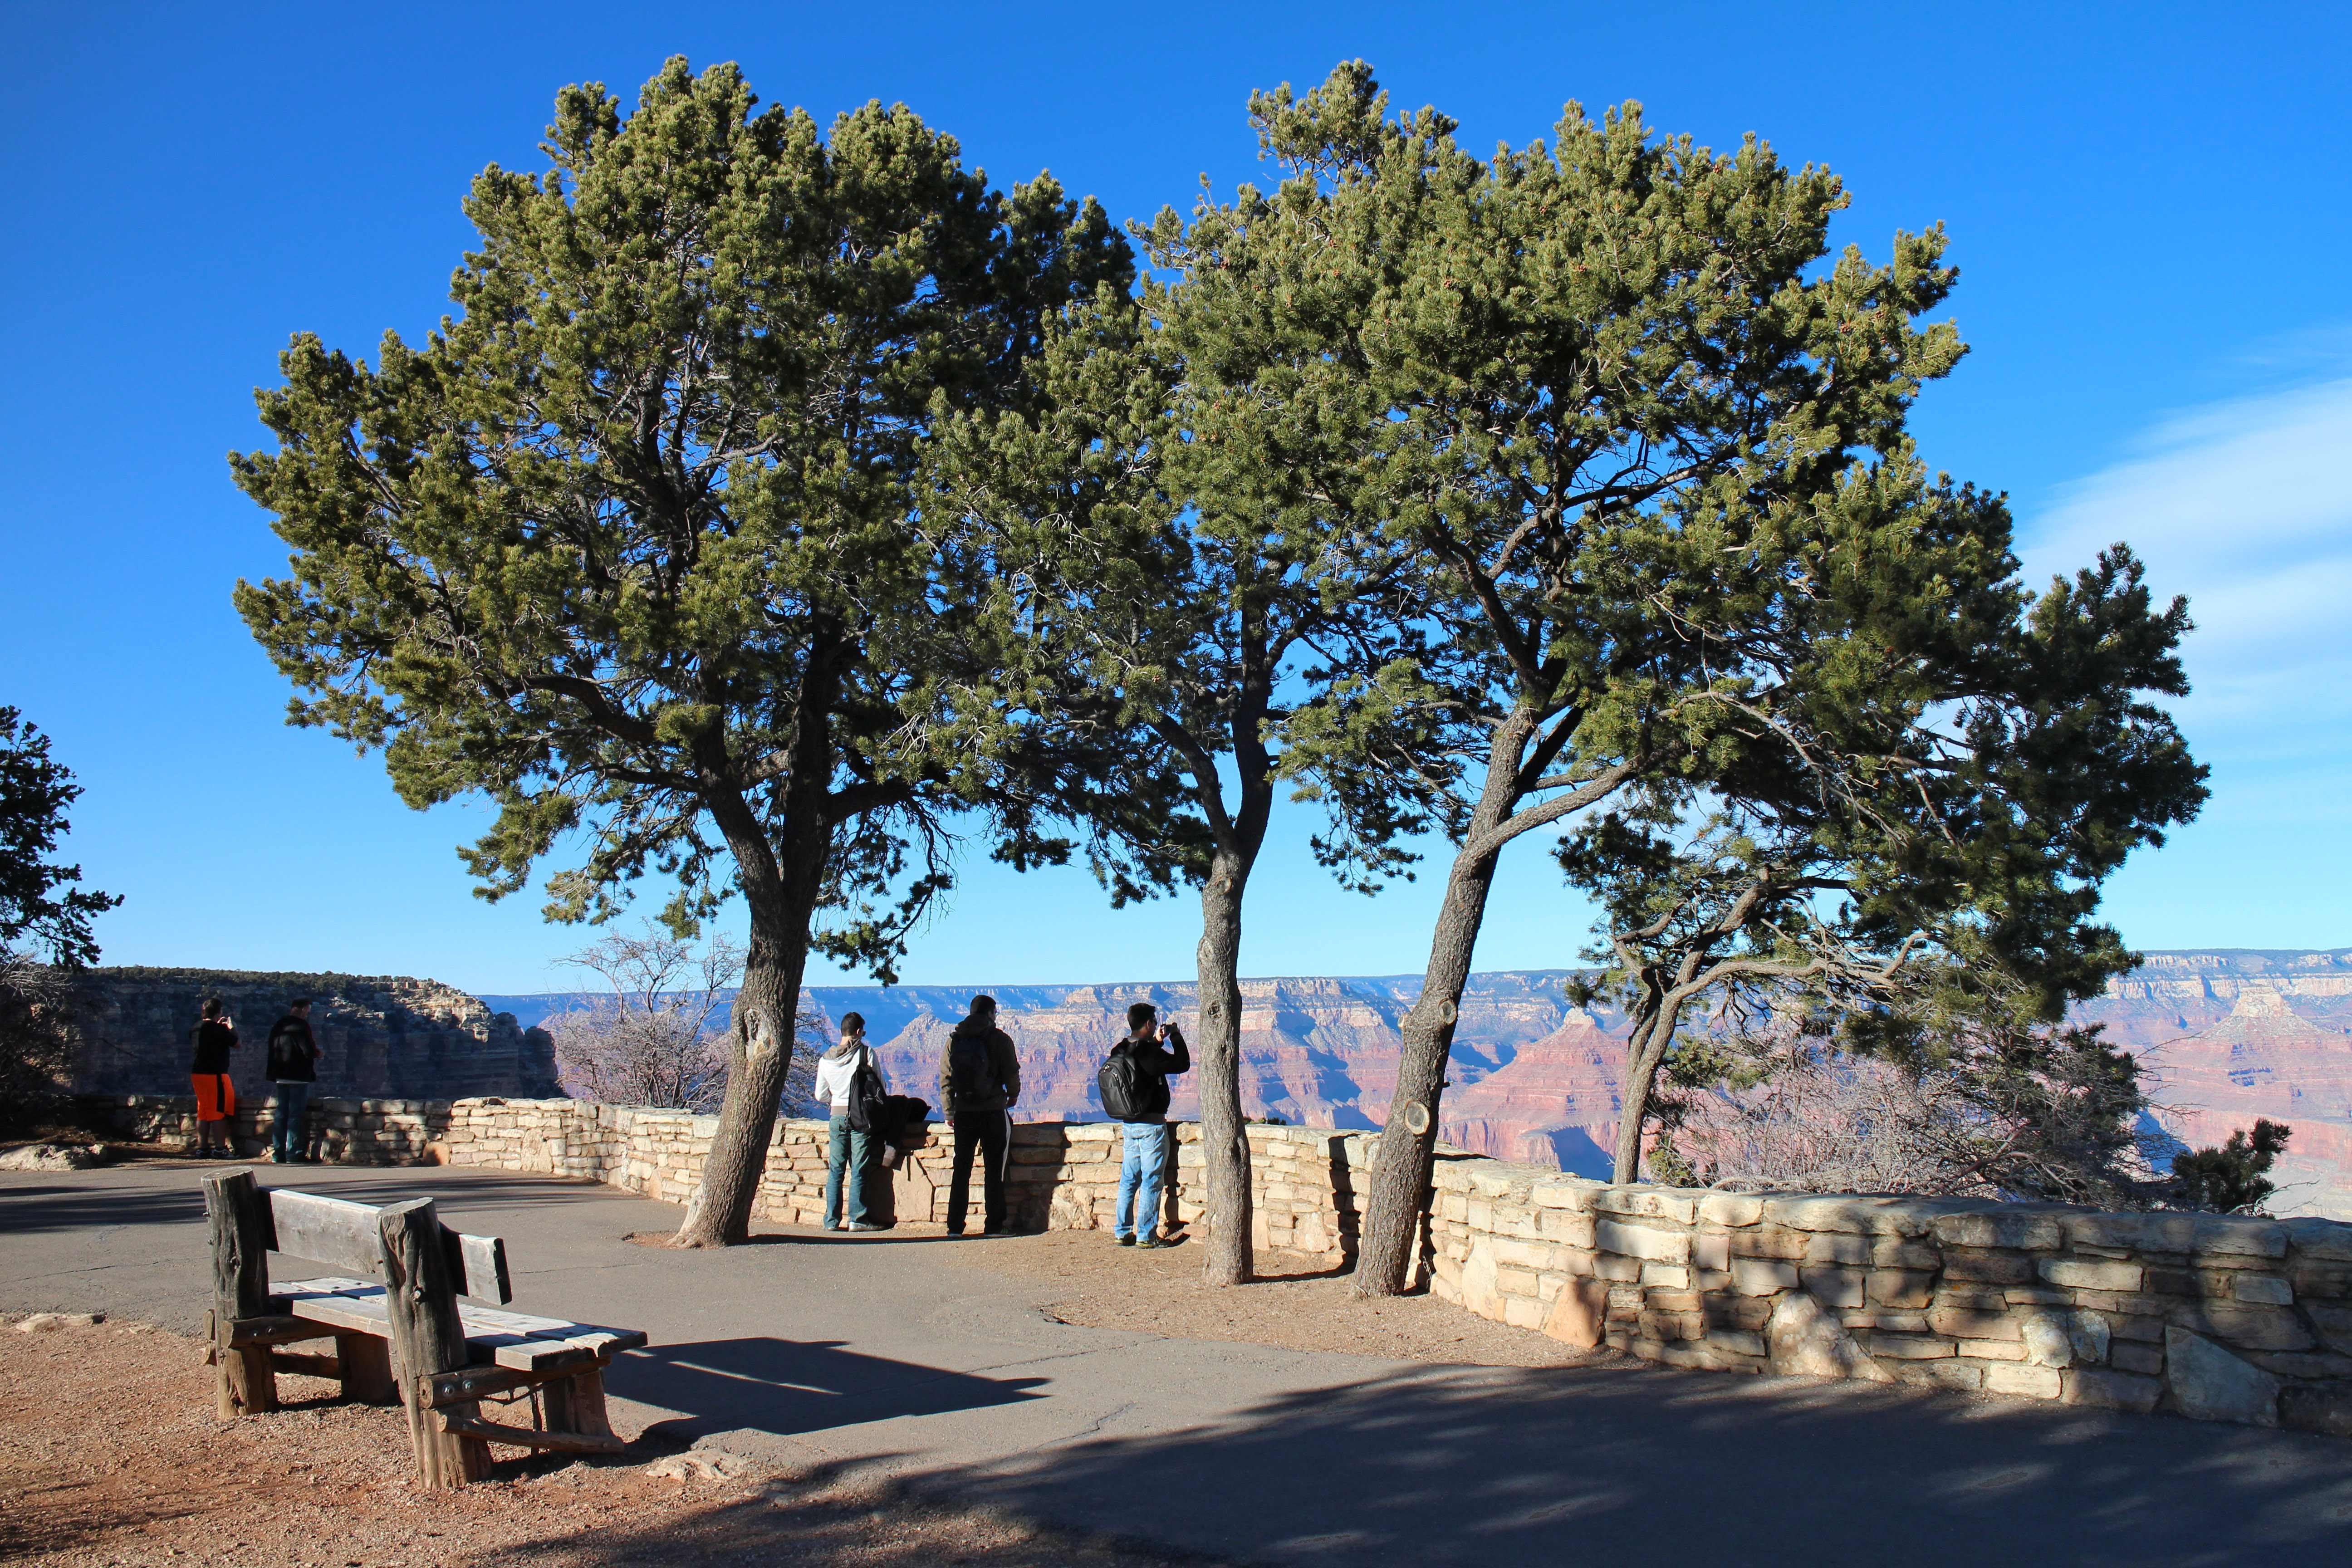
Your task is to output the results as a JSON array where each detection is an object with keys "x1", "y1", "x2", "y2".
[{"x1": 604, "y1": 1338, "x2": 1047, "y2": 1446}]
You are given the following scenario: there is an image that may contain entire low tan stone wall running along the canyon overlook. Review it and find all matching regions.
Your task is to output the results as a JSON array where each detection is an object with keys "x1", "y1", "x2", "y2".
[{"x1": 89, "y1": 1098, "x2": 2352, "y2": 1436}]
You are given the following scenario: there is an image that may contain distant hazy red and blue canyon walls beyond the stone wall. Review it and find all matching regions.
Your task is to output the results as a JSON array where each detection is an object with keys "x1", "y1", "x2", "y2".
[{"x1": 482, "y1": 947, "x2": 2352, "y2": 1218}]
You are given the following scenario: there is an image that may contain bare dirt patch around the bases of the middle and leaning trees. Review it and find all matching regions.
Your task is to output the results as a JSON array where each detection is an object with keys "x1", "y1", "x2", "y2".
[{"x1": 948, "y1": 1230, "x2": 1618, "y2": 1366}]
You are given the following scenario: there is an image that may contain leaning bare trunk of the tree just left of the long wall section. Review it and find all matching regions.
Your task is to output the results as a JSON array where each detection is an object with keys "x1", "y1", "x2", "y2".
[{"x1": 1355, "y1": 708, "x2": 1536, "y2": 1295}]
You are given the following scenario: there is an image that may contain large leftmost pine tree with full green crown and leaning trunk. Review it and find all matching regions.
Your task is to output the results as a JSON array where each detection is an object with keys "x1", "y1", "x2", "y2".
[{"x1": 233, "y1": 59, "x2": 1134, "y2": 1246}]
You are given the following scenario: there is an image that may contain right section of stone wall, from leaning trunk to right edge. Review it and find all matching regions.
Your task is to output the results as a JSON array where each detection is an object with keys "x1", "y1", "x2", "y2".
[{"x1": 1430, "y1": 1159, "x2": 2352, "y2": 1436}]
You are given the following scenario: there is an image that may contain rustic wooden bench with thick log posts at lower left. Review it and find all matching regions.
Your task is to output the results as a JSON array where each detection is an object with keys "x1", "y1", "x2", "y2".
[{"x1": 205, "y1": 1171, "x2": 644, "y2": 1488}]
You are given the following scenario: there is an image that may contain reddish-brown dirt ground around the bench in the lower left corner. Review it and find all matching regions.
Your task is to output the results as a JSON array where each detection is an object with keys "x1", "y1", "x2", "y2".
[{"x1": 0, "y1": 1323, "x2": 1232, "y2": 1568}]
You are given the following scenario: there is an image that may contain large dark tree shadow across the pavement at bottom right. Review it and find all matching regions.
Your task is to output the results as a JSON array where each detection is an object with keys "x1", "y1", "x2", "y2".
[{"x1": 910, "y1": 1368, "x2": 2352, "y2": 1568}]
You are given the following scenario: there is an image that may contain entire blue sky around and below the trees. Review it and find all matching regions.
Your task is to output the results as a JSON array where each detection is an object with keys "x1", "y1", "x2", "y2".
[{"x1": 0, "y1": 0, "x2": 2352, "y2": 992}]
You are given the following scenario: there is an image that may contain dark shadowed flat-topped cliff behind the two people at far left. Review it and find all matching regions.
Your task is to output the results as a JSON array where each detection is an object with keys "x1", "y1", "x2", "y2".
[{"x1": 73, "y1": 969, "x2": 560, "y2": 1100}]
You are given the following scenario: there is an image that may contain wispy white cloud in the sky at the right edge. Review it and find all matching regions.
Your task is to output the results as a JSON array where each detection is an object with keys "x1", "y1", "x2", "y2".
[{"x1": 2020, "y1": 378, "x2": 2352, "y2": 816}]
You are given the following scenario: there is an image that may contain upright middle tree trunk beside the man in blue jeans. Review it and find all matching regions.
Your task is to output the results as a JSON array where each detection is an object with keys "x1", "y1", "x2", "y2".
[{"x1": 1192, "y1": 851, "x2": 1254, "y2": 1286}]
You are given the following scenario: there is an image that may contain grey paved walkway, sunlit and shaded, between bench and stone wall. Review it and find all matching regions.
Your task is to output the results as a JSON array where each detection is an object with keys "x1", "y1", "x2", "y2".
[{"x1": 0, "y1": 1164, "x2": 2352, "y2": 1568}]
